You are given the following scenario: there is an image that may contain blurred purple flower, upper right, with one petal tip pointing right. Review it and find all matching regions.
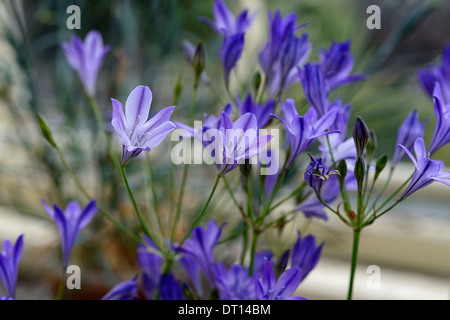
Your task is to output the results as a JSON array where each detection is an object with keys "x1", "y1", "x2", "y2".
[{"x1": 319, "y1": 40, "x2": 366, "y2": 90}]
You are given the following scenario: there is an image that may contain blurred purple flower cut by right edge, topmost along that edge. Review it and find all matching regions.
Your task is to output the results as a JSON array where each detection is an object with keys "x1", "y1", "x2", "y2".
[{"x1": 417, "y1": 45, "x2": 450, "y2": 102}]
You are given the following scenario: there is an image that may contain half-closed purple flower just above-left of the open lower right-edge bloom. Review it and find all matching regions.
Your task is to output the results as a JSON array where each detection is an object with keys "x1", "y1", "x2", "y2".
[{"x1": 391, "y1": 110, "x2": 425, "y2": 168}]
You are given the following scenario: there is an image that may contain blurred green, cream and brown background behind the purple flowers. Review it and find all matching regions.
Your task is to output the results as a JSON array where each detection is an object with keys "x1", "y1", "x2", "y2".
[{"x1": 0, "y1": 0, "x2": 450, "y2": 299}]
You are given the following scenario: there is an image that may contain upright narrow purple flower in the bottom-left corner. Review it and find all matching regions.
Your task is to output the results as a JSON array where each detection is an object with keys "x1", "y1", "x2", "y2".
[{"x1": 0, "y1": 235, "x2": 23, "y2": 300}]
